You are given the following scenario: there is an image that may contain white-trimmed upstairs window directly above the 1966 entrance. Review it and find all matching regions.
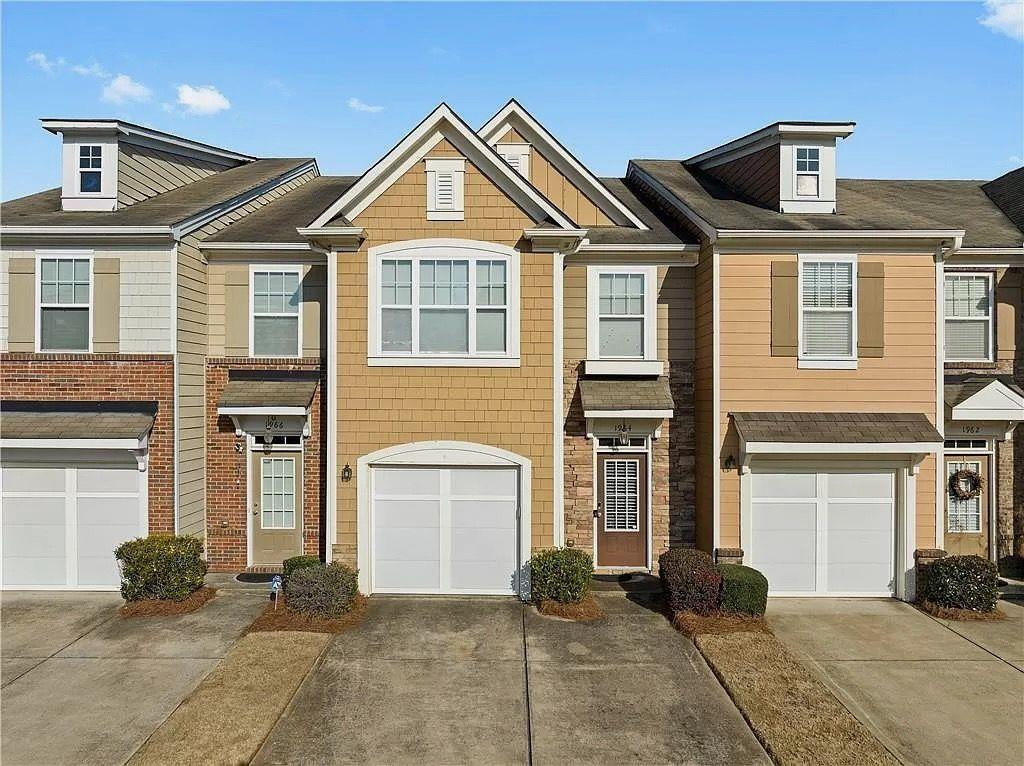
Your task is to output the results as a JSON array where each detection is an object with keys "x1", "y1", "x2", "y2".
[{"x1": 250, "y1": 267, "x2": 302, "y2": 356}]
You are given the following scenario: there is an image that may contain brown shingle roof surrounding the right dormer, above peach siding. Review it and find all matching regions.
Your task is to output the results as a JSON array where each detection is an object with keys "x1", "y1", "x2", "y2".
[{"x1": 631, "y1": 160, "x2": 1024, "y2": 247}]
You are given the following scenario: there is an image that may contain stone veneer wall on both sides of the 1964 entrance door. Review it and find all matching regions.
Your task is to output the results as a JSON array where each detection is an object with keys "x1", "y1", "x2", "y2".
[{"x1": 563, "y1": 359, "x2": 696, "y2": 568}]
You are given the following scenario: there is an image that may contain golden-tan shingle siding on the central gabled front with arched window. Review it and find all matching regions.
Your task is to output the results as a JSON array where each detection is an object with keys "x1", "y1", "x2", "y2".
[{"x1": 335, "y1": 141, "x2": 554, "y2": 563}]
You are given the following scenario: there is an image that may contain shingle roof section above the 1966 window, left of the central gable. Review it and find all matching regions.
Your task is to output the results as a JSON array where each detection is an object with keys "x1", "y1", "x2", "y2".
[{"x1": 207, "y1": 175, "x2": 357, "y2": 243}]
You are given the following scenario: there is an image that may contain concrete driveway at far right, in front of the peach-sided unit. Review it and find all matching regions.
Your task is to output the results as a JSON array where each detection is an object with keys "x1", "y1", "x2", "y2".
[{"x1": 768, "y1": 599, "x2": 1024, "y2": 766}]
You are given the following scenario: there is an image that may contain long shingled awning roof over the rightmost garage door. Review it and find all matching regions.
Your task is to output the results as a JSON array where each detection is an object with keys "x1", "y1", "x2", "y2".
[{"x1": 730, "y1": 413, "x2": 942, "y2": 444}]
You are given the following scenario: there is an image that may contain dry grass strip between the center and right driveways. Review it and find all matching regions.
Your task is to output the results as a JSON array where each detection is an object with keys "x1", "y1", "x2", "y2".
[{"x1": 693, "y1": 633, "x2": 899, "y2": 766}]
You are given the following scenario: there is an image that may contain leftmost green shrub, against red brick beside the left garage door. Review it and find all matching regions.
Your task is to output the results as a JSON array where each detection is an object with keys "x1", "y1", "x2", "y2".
[{"x1": 114, "y1": 535, "x2": 206, "y2": 601}]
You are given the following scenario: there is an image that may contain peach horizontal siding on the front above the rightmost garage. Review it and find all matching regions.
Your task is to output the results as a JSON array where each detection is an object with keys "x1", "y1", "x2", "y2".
[{"x1": 719, "y1": 255, "x2": 936, "y2": 548}]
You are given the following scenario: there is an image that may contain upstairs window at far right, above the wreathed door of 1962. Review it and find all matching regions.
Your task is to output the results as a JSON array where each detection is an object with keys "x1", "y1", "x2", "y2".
[{"x1": 943, "y1": 272, "x2": 992, "y2": 361}]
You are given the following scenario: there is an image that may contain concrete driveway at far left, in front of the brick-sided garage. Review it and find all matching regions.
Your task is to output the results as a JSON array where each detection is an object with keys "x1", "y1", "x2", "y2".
[{"x1": 0, "y1": 591, "x2": 265, "y2": 766}]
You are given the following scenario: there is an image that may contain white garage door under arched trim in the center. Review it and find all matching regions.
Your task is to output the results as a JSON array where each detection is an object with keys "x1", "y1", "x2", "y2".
[{"x1": 372, "y1": 467, "x2": 519, "y2": 594}]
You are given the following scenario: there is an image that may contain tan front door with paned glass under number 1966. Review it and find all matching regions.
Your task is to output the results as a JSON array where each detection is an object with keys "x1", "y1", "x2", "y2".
[{"x1": 251, "y1": 452, "x2": 302, "y2": 566}]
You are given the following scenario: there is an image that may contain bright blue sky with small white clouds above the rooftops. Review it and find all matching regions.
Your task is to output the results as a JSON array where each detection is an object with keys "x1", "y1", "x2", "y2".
[{"x1": 2, "y1": 0, "x2": 1024, "y2": 199}]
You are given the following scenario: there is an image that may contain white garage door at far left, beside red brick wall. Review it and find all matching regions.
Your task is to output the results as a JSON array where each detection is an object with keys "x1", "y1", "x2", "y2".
[{"x1": 0, "y1": 460, "x2": 146, "y2": 590}]
